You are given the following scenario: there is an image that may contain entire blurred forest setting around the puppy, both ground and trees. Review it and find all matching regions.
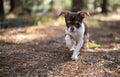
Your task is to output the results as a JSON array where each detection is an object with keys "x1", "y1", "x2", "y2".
[{"x1": 0, "y1": 0, "x2": 120, "y2": 77}]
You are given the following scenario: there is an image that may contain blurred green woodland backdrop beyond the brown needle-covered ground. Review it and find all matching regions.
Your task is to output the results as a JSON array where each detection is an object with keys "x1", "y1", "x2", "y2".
[{"x1": 0, "y1": 0, "x2": 120, "y2": 28}]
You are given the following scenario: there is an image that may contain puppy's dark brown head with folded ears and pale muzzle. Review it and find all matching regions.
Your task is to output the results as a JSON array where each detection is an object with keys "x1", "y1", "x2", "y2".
[{"x1": 60, "y1": 11, "x2": 89, "y2": 32}]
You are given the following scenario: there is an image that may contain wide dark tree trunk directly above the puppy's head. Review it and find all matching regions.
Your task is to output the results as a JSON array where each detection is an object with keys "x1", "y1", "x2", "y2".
[{"x1": 72, "y1": 0, "x2": 84, "y2": 12}]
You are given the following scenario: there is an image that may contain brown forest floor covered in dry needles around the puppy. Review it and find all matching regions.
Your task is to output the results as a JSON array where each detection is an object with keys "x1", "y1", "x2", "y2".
[{"x1": 0, "y1": 12, "x2": 120, "y2": 77}]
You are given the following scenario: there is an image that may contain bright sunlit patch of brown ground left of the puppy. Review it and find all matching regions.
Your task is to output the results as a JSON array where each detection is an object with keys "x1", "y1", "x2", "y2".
[{"x1": 0, "y1": 26, "x2": 63, "y2": 43}]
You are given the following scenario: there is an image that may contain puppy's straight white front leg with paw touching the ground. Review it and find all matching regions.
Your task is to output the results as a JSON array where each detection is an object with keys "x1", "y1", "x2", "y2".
[{"x1": 71, "y1": 39, "x2": 84, "y2": 60}]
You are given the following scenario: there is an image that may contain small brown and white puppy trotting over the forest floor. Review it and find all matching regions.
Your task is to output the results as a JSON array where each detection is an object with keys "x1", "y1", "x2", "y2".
[{"x1": 60, "y1": 11, "x2": 89, "y2": 60}]
